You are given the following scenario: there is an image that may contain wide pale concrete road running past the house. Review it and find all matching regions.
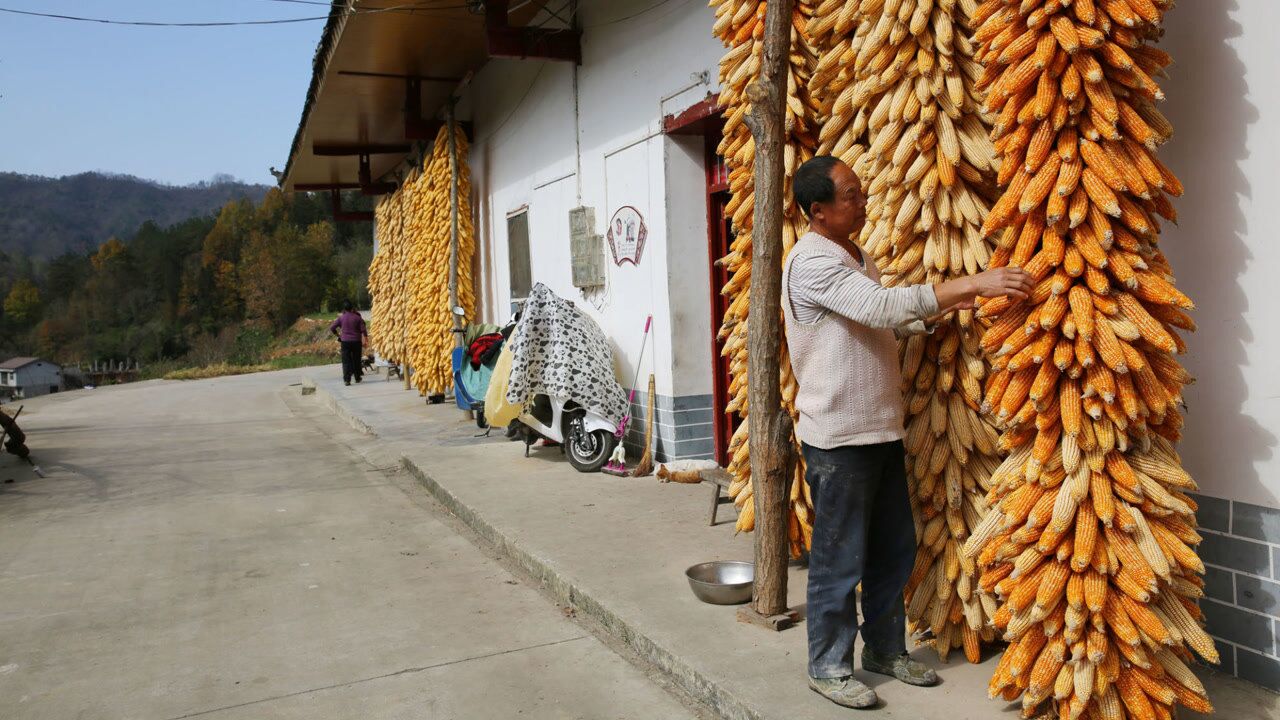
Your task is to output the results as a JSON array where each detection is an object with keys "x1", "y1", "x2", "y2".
[{"x1": 0, "y1": 372, "x2": 695, "y2": 720}]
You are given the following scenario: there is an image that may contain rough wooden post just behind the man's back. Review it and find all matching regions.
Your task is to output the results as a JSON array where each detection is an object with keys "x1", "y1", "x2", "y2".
[{"x1": 739, "y1": 0, "x2": 795, "y2": 629}]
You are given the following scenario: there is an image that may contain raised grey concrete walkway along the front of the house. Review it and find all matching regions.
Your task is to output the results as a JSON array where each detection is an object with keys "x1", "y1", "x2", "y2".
[{"x1": 304, "y1": 373, "x2": 1280, "y2": 720}]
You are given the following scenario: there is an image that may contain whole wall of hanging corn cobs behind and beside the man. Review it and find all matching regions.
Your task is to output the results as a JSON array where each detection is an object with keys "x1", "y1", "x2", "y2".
[{"x1": 713, "y1": 0, "x2": 1217, "y2": 702}]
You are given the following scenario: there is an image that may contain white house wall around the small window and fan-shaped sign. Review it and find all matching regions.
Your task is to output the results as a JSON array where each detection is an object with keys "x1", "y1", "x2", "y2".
[{"x1": 461, "y1": 0, "x2": 721, "y2": 395}]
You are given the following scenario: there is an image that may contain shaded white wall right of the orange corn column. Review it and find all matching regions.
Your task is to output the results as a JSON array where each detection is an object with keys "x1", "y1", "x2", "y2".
[{"x1": 1160, "y1": 0, "x2": 1280, "y2": 507}]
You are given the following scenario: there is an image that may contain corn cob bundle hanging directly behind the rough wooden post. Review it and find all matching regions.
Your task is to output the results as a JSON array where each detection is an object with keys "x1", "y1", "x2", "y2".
[{"x1": 710, "y1": 0, "x2": 817, "y2": 555}]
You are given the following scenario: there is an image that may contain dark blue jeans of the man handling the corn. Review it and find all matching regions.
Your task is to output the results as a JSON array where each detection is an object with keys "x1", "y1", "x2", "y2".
[{"x1": 803, "y1": 441, "x2": 915, "y2": 678}]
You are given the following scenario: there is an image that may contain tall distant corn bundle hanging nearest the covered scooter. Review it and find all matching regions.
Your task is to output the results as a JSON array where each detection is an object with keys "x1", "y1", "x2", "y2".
[{"x1": 404, "y1": 122, "x2": 475, "y2": 395}]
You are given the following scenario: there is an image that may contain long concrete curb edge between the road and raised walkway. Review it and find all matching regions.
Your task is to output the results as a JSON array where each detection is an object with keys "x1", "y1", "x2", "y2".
[{"x1": 307, "y1": 386, "x2": 773, "y2": 720}]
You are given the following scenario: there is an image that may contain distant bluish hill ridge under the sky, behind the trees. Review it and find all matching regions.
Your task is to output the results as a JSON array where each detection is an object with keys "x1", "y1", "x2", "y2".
[{"x1": 0, "y1": 173, "x2": 269, "y2": 259}]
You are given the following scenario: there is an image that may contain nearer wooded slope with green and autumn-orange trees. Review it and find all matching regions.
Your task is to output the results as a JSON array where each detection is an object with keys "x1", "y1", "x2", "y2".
[{"x1": 0, "y1": 188, "x2": 372, "y2": 364}]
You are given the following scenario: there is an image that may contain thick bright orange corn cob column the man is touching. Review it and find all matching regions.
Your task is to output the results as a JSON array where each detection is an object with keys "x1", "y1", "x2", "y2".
[{"x1": 964, "y1": 0, "x2": 1217, "y2": 720}]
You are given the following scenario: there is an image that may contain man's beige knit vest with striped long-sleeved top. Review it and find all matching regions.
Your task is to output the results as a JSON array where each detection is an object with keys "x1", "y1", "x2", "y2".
[{"x1": 782, "y1": 233, "x2": 938, "y2": 450}]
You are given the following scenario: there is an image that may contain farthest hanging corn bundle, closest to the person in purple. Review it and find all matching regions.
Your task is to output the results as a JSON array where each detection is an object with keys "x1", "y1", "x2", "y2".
[{"x1": 369, "y1": 179, "x2": 407, "y2": 363}]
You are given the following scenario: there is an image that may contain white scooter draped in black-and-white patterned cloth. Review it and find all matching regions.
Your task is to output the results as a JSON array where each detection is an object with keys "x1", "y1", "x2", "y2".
[{"x1": 499, "y1": 283, "x2": 627, "y2": 473}]
